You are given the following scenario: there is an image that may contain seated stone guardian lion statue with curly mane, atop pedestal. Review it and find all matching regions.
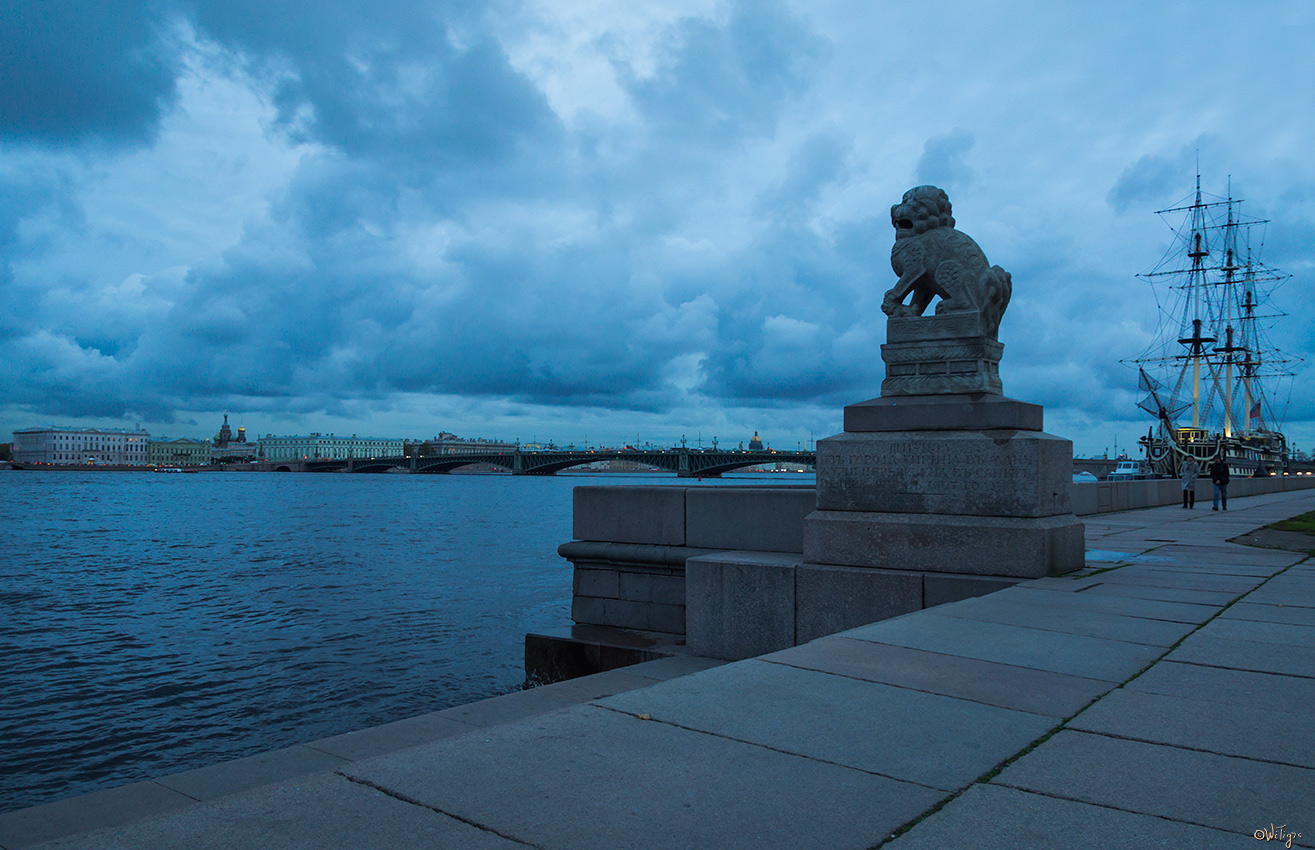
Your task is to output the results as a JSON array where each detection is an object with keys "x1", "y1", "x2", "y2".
[{"x1": 881, "y1": 186, "x2": 1013, "y2": 339}]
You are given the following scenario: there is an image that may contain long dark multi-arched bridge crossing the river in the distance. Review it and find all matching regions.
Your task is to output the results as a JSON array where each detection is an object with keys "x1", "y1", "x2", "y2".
[{"x1": 299, "y1": 447, "x2": 817, "y2": 478}]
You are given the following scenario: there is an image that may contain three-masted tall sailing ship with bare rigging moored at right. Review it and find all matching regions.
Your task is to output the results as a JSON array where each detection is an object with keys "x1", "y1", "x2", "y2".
[{"x1": 1132, "y1": 174, "x2": 1293, "y2": 476}]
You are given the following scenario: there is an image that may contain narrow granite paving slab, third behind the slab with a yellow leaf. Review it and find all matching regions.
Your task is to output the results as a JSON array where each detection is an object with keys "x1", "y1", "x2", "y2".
[{"x1": 936, "y1": 595, "x2": 1197, "y2": 646}]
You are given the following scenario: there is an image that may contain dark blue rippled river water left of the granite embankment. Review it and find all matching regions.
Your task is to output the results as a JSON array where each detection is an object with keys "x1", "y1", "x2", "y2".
[{"x1": 0, "y1": 471, "x2": 813, "y2": 812}]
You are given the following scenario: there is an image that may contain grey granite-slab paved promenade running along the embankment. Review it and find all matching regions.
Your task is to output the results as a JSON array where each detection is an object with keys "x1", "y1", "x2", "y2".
[{"x1": 0, "y1": 491, "x2": 1315, "y2": 850}]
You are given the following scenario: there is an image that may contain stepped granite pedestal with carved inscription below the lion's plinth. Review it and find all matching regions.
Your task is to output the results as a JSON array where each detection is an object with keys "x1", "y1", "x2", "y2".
[{"x1": 796, "y1": 392, "x2": 1085, "y2": 652}]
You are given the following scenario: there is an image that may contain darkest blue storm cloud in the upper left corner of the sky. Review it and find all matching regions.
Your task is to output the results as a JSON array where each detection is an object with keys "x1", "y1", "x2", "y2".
[{"x1": 0, "y1": 0, "x2": 179, "y2": 145}]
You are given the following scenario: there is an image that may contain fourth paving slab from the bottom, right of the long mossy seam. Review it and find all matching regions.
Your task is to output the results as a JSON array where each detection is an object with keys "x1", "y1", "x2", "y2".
[{"x1": 1123, "y1": 659, "x2": 1315, "y2": 714}]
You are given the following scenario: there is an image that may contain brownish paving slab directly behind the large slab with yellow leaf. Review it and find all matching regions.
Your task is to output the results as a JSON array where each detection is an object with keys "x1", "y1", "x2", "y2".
[{"x1": 760, "y1": 636, "x2": 1110, "y2": 718}]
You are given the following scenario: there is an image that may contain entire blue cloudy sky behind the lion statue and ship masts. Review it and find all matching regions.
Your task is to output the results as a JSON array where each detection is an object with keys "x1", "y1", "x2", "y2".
[{"x1": 0, "y1": 0, "x2": 1315, "y2": 454}]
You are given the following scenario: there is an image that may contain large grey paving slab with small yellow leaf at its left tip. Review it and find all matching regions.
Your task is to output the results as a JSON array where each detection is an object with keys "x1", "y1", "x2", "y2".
[{"x1": 598, "y1": 661, "x2": 1057, "y2": 791}]
